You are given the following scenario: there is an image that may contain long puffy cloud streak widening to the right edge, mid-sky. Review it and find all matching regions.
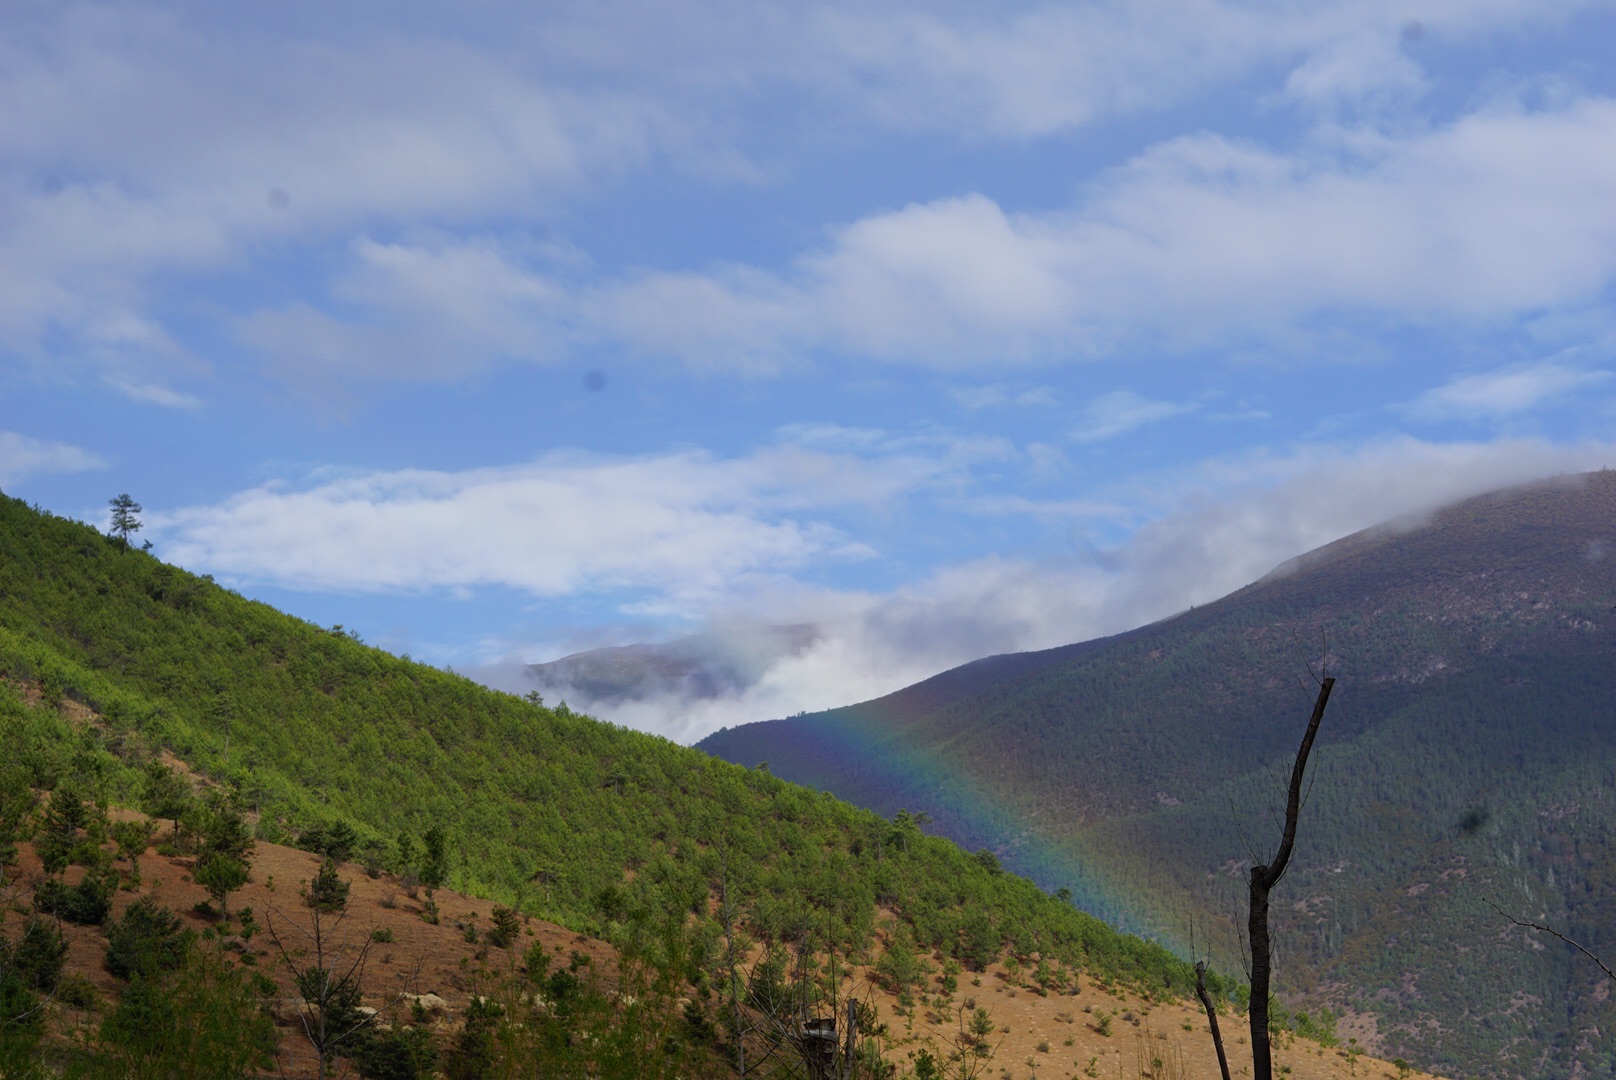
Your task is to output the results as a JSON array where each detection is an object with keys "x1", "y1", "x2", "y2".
[{"x1": 587, "y1": 100, "x2": 1616, "y2": 367}]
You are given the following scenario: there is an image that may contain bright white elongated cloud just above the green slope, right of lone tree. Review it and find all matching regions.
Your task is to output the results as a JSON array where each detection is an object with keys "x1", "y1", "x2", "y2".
[{"x1": 149, "y1": 445, "x2": 952, "y2": 611}]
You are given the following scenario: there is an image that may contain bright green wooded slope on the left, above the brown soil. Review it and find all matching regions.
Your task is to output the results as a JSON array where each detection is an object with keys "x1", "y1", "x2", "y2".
[{"x1": 0, "y1": 498, "x2": 1193, "y2": 1047}]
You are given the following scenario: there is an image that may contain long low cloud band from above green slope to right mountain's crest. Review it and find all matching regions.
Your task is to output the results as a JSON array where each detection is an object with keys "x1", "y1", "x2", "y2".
[{"x1": 150, "y1": 432, "x2": 1616, "y2": 740}]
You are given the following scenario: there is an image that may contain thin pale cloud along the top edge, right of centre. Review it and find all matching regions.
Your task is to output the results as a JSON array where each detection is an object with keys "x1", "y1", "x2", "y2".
[{"x1": 803, "y1": 0, "x2": 1589, "y2": 137}]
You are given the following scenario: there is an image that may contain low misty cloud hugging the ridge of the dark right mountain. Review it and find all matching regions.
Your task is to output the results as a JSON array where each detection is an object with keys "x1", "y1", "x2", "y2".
[{"x1": 482, "y1": 438, "x2": 1616, "y2": 740}]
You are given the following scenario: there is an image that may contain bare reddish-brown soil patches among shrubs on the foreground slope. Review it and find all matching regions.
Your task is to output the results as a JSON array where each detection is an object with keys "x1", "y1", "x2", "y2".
[{"x1": 5, "y1": 827, "x2": 1425, "y2": 1080}]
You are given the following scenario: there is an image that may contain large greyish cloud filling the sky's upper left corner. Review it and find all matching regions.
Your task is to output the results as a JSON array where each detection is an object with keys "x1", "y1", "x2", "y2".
[{"x1": 0, "y1": 5, "x2": 656, "y2": 386}]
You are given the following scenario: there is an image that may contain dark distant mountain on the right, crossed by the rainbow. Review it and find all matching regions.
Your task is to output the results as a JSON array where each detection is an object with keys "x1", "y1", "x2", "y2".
[{"x1": 701, "y1": 472, "x2": 1616, "y2": 1080}]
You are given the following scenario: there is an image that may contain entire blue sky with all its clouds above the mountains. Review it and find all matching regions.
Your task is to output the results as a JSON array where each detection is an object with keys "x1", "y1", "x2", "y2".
[{"x1": 0, "y1": 0, "x2": 1616, "y2": 740}]
